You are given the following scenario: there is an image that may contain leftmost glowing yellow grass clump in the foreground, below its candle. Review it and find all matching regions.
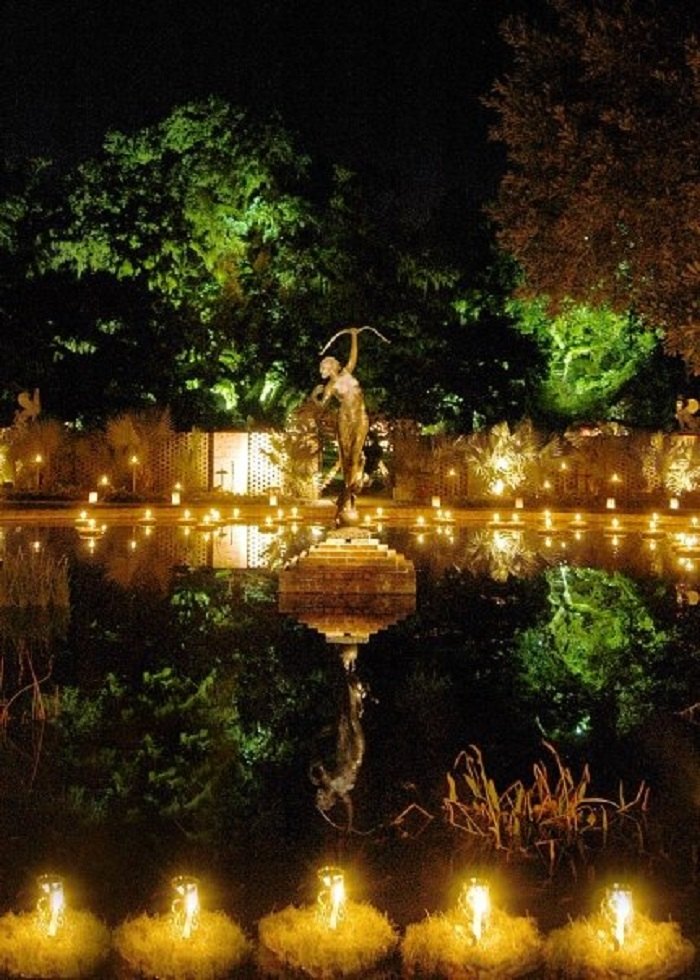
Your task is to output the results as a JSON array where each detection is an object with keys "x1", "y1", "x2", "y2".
[{"x1": 0, "y1": 909, "x2": 110, "y2": 977}]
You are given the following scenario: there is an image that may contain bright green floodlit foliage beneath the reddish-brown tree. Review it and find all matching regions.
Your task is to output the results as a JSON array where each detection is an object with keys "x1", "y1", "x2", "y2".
[{"x1": 510, "y1": 298, "x2": 658, "y2": 419}]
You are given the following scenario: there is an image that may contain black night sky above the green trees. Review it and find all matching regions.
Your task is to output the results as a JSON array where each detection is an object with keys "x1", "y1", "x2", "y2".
[{"x1": 0, "y1": 0, "x2": 527, "y2": 212}]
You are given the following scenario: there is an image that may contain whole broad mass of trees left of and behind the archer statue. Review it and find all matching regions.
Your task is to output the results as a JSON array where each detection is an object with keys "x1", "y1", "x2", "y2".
[{"x1": 35, "y1": 99, "x2": 492, "y2": 424}]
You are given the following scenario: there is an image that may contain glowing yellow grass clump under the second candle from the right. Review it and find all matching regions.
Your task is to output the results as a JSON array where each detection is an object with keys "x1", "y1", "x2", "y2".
[{"x1": 401, "y1": 909, "x2": 542, "y2": 980}]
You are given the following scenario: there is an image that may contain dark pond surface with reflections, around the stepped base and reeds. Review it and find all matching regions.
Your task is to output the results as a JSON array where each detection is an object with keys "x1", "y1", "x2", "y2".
[{"x1": 0, "y1": 524, "x2": 700, "y2": 964}]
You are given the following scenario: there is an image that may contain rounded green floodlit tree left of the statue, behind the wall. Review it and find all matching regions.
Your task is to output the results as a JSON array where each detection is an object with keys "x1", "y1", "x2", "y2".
[{"x1": 40, "y1": 99, "x2": 316, "y2": 420}]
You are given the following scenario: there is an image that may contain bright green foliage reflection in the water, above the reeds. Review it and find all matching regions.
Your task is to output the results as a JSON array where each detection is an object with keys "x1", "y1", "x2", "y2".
[{"x1": 515, "y1": 565, "x2": 673, "y2": 736}]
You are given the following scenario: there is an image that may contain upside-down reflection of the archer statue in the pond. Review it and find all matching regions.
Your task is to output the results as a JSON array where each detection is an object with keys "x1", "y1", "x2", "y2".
[{"x1": 309, "y1": 644, "x2": 367, "y2": 831}]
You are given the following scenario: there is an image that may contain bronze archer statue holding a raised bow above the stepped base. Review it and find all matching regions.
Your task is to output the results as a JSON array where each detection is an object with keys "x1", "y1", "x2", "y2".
[{"x1": 312, "y1": 327, "x2": 388, "y2": 526}]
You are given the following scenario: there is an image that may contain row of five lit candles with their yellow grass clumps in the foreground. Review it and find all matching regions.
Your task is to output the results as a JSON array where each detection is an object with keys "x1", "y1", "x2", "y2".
[{"x1": 0, "y1": 866, "x2": 695, "y2": 978}]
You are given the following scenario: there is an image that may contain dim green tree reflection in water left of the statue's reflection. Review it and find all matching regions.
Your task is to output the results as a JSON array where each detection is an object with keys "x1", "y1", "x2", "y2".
[{"x1": 54, "y1": 572, "x2": 332, "y2": 836}]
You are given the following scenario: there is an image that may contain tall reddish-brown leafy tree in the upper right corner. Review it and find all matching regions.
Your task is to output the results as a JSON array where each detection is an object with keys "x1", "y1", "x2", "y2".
[{"x1": 488, "y1": 0, "x2": 700, "y2": 373}]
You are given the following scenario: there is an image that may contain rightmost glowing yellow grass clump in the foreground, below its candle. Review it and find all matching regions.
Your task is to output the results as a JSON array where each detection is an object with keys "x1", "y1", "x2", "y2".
[{"x1": 544, "y1": 912, "x2": 695, "y2": 980}]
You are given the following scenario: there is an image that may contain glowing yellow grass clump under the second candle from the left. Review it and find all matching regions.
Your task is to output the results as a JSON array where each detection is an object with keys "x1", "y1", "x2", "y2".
[{"x1": 114, "y1": 911, "x2": 250, "y2": 980}]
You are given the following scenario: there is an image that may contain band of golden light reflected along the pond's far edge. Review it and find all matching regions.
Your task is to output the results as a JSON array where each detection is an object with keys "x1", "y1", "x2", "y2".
[{"x1": 0, "y1": 520, "x2": 700, "y2": 603}]
